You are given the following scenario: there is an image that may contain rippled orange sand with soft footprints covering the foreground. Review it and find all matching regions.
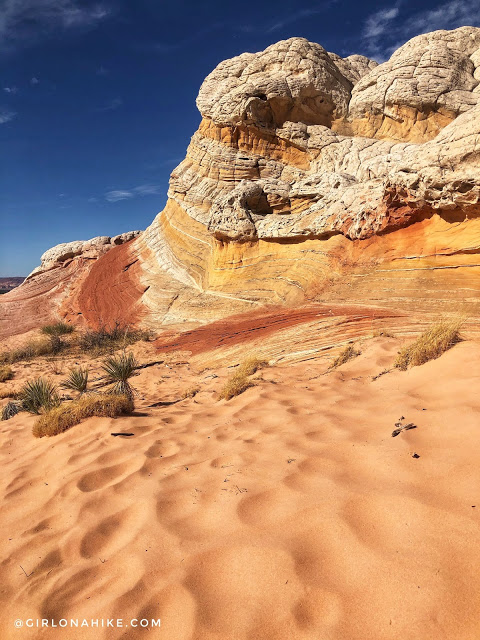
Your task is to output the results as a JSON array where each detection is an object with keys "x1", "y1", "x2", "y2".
[{"x1": 0, "y1": 308, "x2": 480, "y2": 640}]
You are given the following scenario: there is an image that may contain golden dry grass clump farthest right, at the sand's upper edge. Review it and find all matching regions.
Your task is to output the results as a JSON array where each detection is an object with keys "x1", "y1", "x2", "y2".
[{"x1": 394, "y1": 320, "x2": 462, "y2": 371}]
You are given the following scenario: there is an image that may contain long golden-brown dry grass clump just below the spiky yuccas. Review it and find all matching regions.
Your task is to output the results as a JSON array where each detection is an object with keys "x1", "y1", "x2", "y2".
[{"x1": 32, "y1": 393, "x2": 135, "y2": 438}]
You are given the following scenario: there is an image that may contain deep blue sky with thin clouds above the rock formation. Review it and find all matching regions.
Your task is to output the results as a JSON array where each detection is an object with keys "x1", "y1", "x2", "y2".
[{"x1": 0, "y1": 0, "x2": 480, "y2": 276}]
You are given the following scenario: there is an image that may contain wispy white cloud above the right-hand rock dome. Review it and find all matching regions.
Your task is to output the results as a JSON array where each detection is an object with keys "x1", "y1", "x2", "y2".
[{"x1": 362, "y1": 0, "x2": 480, "y2": 62}]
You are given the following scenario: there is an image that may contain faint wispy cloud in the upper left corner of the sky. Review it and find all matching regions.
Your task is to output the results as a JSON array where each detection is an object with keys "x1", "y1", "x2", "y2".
[{"x1": 0, "y1": 0, "x2": 110, "y2": 49}]
